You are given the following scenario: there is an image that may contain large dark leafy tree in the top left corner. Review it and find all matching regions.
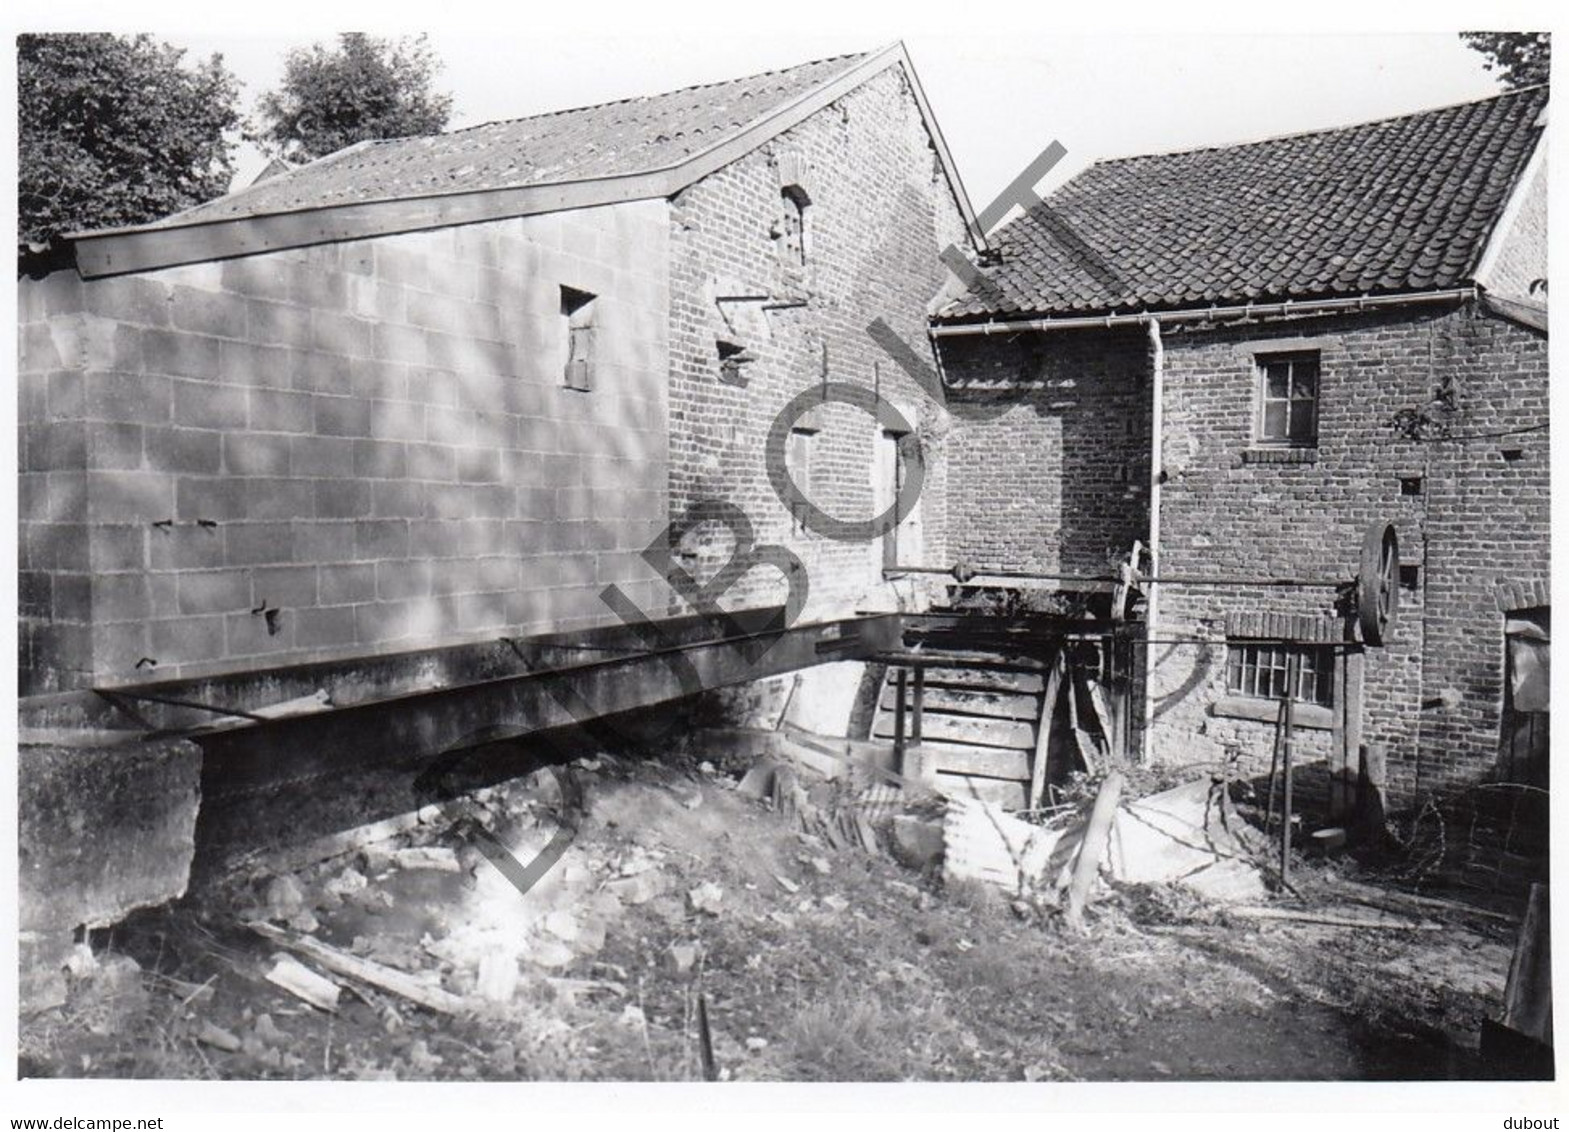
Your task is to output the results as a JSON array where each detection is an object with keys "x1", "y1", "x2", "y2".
[{"x1": 17, "y1": 33, "x2": 240, "y2": 251}]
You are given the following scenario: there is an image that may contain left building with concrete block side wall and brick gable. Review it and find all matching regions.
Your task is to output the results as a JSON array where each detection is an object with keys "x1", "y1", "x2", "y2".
[{"x1": 20, "y1": 44, "x2": 977, "y2": 694}]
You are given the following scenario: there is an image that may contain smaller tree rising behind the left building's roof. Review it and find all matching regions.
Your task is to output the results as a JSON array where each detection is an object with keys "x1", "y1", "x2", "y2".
[{"x1": 246, "y1": 31, "x2": 452, "y2": 160}]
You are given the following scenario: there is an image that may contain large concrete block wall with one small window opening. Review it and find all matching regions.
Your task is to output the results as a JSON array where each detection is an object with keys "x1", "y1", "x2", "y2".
[{"x1": 20, "y1": 201, "x2": 670, "y2": 692}]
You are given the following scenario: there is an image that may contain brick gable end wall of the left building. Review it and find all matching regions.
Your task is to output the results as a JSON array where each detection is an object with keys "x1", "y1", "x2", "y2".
[{"x1": 670, "y1": 68, "x2": 967, "y2": 615}]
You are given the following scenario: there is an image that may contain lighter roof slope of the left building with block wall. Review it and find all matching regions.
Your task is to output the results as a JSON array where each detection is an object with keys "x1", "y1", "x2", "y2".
[{"x1": 162, "y1": 55, "x2": 866, "y2": 226}]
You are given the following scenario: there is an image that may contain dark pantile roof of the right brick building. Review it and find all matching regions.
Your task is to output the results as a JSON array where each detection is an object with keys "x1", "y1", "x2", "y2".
[{"x1": 938, "y1": 86, "x2": 1547, "y2": 320}]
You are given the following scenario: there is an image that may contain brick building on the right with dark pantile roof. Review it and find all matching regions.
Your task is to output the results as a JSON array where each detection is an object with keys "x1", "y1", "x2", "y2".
[{"x1": 934, "y1": 88, "x2": 1550, "y2": 801}]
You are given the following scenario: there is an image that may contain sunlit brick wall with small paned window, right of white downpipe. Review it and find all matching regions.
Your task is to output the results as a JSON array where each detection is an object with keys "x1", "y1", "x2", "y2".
[{"x1": 1153, "y1": 308, "x2": 1549, "y2": 801}]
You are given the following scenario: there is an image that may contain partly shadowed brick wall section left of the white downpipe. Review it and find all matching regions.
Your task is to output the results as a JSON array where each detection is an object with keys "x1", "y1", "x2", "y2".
[{"x1": 943, "y1": 327, "x2": 1150, "y2": 575}]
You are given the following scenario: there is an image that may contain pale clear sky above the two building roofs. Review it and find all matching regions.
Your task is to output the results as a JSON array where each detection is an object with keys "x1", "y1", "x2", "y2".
[{"x1": 162, "y1": 30, "x2": 1498, "y2": 209}]
